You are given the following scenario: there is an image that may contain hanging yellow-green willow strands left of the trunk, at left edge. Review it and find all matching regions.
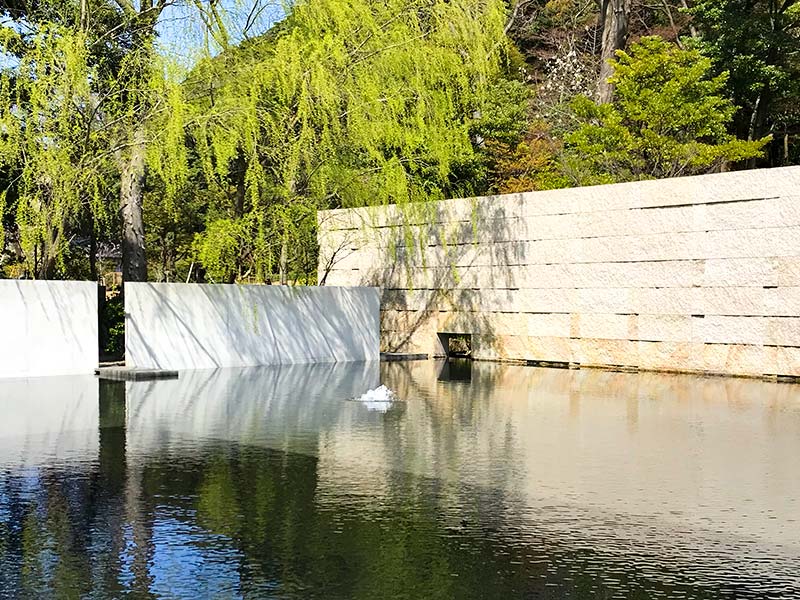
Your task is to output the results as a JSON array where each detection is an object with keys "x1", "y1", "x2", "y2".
[{"x1": 0, "y1": 25, "x2": 114, "y2": 278}]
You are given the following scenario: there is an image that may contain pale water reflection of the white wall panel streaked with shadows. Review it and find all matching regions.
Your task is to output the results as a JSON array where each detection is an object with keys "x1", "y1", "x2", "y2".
[{"x1": 126, "y1": 361, "x2": 380, "y2": 454}]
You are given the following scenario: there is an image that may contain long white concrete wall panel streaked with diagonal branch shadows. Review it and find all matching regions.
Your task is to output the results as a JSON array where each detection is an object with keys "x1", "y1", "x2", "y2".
[{"x1": 125, "y1": 283, "x2": 380, "y2": 370}]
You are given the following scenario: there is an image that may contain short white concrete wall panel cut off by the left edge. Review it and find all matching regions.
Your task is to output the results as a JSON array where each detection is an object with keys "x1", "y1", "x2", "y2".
[{"x1": 0, "y1": 279, "x2": 99, "y2": 377}]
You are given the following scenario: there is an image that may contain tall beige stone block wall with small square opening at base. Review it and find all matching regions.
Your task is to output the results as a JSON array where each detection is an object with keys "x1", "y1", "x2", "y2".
[{"x1": 319, "y1": 167, "x2": 800, "y2": 376}]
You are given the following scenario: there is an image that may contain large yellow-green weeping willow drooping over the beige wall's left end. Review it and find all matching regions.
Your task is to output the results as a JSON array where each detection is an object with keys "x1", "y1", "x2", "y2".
[{"x1": 160, "y1": 0, "x2": 506, "y2": 283}]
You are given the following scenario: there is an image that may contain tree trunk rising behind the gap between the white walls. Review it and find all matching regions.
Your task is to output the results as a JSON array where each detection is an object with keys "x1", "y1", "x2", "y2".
[{"x1": 120, "y1": 127, "x2": 147, "y2": 281}]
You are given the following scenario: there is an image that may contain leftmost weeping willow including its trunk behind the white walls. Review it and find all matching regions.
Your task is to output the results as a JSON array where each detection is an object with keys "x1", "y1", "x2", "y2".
[{"x1": 0, "y1": 0, "x2": 238, "y2": 281}]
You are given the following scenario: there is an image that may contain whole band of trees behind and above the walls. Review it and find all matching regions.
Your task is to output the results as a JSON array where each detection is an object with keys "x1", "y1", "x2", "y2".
[{"x1": 0, "y1": 0, "x2": 800, "y2": 283}]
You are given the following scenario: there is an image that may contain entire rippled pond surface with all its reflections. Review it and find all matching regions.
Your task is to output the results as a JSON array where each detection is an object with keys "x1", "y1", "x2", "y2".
[{"x1": 0, "y1": 361, "x2": 800, "y2": 599}]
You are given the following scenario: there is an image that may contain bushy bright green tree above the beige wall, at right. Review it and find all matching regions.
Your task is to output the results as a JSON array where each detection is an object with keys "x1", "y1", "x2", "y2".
[{"x1": 566, "y1": 37, "x2": 768, "y2": 183}]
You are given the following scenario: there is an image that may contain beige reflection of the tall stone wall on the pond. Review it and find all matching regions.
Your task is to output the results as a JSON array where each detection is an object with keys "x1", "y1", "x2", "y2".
[{"x1": 312, "y1": 362, "x2": 800, "y2": 559}]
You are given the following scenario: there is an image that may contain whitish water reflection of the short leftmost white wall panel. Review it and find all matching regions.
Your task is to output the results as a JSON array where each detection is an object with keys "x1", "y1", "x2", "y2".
[{"x1": 0, "y1": 375, "x2": 99, "y2": 469}]
